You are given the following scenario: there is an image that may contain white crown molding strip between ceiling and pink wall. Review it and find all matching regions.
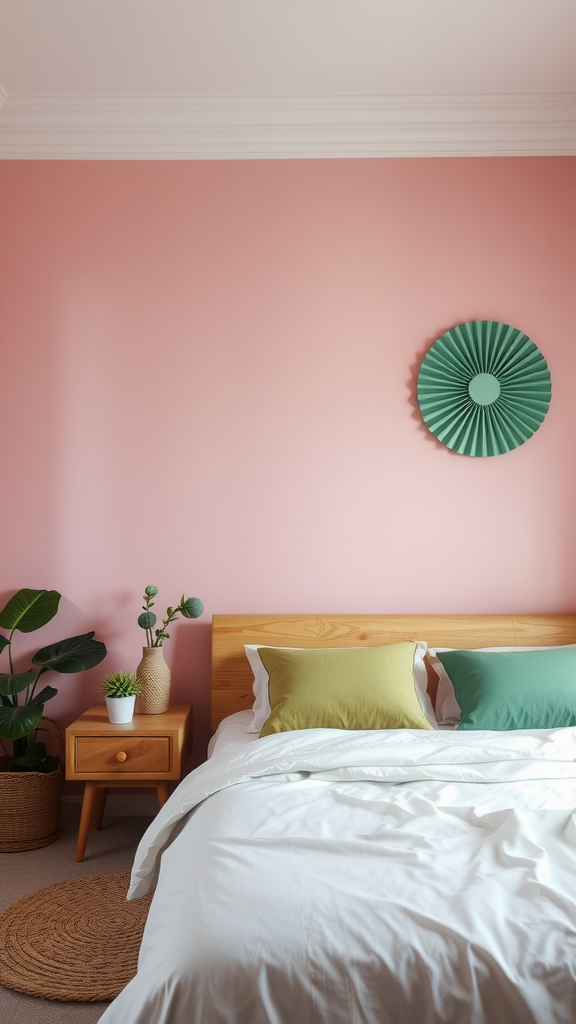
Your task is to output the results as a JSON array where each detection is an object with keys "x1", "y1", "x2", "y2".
[{"x1": 0, "y1": 91, "x2": 576, "y2": 160}]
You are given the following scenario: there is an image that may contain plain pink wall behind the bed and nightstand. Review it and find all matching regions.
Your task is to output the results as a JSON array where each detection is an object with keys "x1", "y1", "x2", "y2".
[{"x1": 0, "y1": 158, "x2": 576, "y2": 760}]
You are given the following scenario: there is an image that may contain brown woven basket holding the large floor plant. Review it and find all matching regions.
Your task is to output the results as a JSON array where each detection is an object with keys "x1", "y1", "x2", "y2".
[{"x1": 0, "y1": 718, "x2": 64, "y2": 853}]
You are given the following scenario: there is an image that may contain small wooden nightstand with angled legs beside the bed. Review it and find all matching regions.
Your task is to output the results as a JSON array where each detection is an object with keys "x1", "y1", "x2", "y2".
[{"x1": 66, "y1": 705, "x2": 192, "y2": 861}]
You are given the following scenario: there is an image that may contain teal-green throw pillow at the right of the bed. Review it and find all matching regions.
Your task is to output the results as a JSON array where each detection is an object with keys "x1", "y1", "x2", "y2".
[{"x1": 437, "y1": 648, "x2": 576, "y2": 729}]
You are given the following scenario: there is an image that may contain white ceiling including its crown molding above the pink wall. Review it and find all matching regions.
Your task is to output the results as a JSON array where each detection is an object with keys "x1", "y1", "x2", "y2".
[{"x1": 0, "y1": 0, "x2": 576, "y2": 158}]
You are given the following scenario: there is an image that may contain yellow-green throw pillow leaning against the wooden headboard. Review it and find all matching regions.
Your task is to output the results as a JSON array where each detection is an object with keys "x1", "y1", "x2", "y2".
[{"x1": 258, "y1": 642, "x2": 431, "y2": 736}]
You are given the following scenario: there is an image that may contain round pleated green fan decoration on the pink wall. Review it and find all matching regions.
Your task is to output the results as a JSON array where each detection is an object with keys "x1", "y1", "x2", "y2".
[{"x1": 417, "y1": 321, "x2": 551, "y2": 458}]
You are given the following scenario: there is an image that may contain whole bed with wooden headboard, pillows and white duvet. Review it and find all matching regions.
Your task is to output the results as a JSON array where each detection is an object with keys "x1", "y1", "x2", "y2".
[{"x1": 96, "y1": 615, "x2": 576, "y2": 1024}]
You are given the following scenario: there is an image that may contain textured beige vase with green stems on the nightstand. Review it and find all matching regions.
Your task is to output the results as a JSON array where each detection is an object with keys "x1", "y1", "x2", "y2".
[{"x1": 136, "y1": 586, "x2": 204, "y2": 715}]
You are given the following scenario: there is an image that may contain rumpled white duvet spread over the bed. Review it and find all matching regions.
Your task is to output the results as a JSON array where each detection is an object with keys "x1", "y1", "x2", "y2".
[{"x1": 101, "y1": 729, "x2": 576, "y2": 1024}]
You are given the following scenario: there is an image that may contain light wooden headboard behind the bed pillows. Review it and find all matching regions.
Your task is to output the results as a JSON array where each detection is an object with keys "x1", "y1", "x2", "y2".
[{"x1": 212, "y1": 615, "x2": 576, "y2": 730}]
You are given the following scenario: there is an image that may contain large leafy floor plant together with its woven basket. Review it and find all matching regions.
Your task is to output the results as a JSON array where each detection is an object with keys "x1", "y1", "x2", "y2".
[{"x1": 0, "y1": 589, "x2": 107, "y2": 852}]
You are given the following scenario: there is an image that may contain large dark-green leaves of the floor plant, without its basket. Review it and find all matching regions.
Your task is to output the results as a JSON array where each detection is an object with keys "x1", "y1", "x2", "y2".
[{"x1": 0, "y1": 590, "x2": 107, "y2": 771}]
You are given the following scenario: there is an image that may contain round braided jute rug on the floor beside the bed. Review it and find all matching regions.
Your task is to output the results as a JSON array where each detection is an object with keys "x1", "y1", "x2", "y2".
[{"x1": 0, "y1": 871, "x2": 152, "y2": 1002}]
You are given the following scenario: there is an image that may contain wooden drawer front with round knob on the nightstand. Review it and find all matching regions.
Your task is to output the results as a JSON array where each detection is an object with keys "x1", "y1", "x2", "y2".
[{"x1": 74, "y1": 736, "x2": 170, "y2": 776}]
